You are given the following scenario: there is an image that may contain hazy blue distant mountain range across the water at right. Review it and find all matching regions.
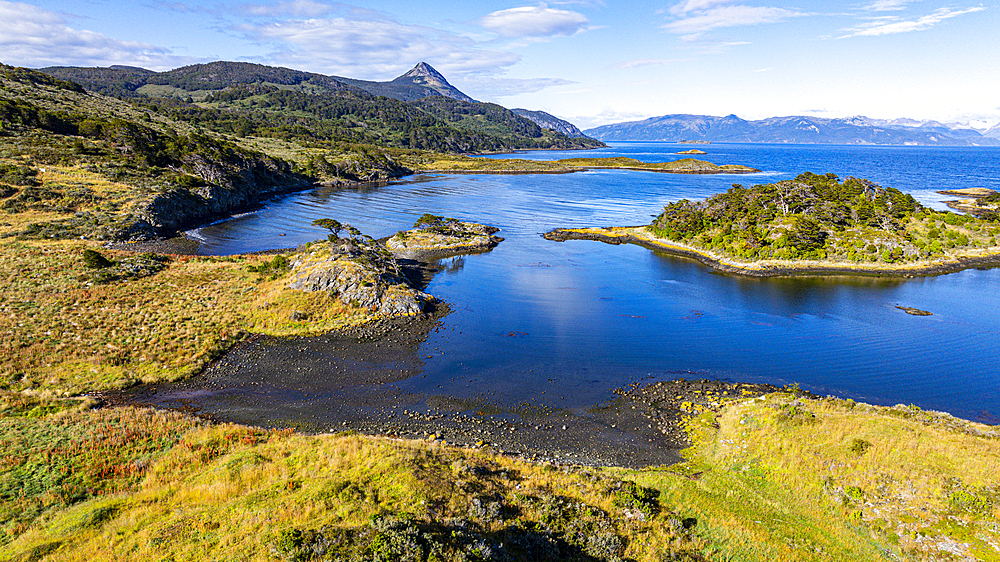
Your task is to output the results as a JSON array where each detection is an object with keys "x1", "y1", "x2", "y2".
[{"x1": 584, "y1": 115, "x2": 1000, "y2": 146}]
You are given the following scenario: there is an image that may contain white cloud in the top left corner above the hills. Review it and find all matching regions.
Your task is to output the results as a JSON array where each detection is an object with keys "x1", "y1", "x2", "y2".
[{"x1": 0, "y1": 0, "x2": 188, "y2": 70}]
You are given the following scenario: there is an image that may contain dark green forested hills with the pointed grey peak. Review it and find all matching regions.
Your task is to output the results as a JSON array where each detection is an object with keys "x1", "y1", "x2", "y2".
[{"x1": 42, "y1": 62, "x2": 603, "y2": 153}]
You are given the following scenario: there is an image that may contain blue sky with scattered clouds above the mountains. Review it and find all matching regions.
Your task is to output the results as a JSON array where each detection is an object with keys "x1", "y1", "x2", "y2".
[{"x1": 0, "y1": 0, "x2": 1000, "y2": 129}]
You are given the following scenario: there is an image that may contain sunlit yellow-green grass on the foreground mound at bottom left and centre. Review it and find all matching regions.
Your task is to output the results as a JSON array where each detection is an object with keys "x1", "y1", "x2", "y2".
[{"x1": 1, "y1": 414, "x2": 703, "y2": 561}]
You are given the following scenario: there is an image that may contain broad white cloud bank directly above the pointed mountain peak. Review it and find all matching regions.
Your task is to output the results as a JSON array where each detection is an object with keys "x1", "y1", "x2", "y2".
[{"x1": 237, "y1": 18, "x2": 520, "y2": 80}]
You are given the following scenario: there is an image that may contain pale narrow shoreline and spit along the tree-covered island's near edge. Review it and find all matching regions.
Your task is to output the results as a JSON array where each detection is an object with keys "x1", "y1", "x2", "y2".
[{"x1": 542, "y1": 226, "x2": 1000, "y2": 278}]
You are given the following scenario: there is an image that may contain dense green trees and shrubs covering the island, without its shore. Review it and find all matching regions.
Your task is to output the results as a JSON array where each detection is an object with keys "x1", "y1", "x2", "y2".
[{"x1": 651, "y1": 172, "x2": 1000, "y2": 263}]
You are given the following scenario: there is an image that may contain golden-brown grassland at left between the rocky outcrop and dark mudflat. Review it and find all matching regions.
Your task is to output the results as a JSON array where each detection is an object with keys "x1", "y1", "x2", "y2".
[{"x1": 0, "y1": 241, "x2": 378, "y2": 395}]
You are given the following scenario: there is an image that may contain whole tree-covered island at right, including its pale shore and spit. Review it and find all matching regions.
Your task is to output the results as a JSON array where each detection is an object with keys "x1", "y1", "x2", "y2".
[{"x1": 545, "y1": 172, "x2": 1000, "y2": 277}]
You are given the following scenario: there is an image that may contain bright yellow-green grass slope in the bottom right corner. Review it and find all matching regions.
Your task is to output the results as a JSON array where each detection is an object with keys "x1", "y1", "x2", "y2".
[{"x1": 635, "y1": 394, "x2": 1000, "y2": 560}]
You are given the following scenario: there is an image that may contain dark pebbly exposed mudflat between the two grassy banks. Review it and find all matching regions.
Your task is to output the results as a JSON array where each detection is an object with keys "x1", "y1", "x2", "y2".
[{"x1": 101, "y1": 300, "x2": 788, "y2": 468}]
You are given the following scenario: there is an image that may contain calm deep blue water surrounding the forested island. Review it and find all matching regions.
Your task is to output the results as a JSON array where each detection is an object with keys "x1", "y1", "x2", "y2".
[{"x1": 190, "y1": 143, "x2": 1000, "y2": 423}]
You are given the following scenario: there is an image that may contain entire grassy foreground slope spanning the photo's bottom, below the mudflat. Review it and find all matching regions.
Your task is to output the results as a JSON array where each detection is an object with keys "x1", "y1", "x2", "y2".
[{"x1": 0, "y1": 393, "x2": 1000, "y2": 561}]
